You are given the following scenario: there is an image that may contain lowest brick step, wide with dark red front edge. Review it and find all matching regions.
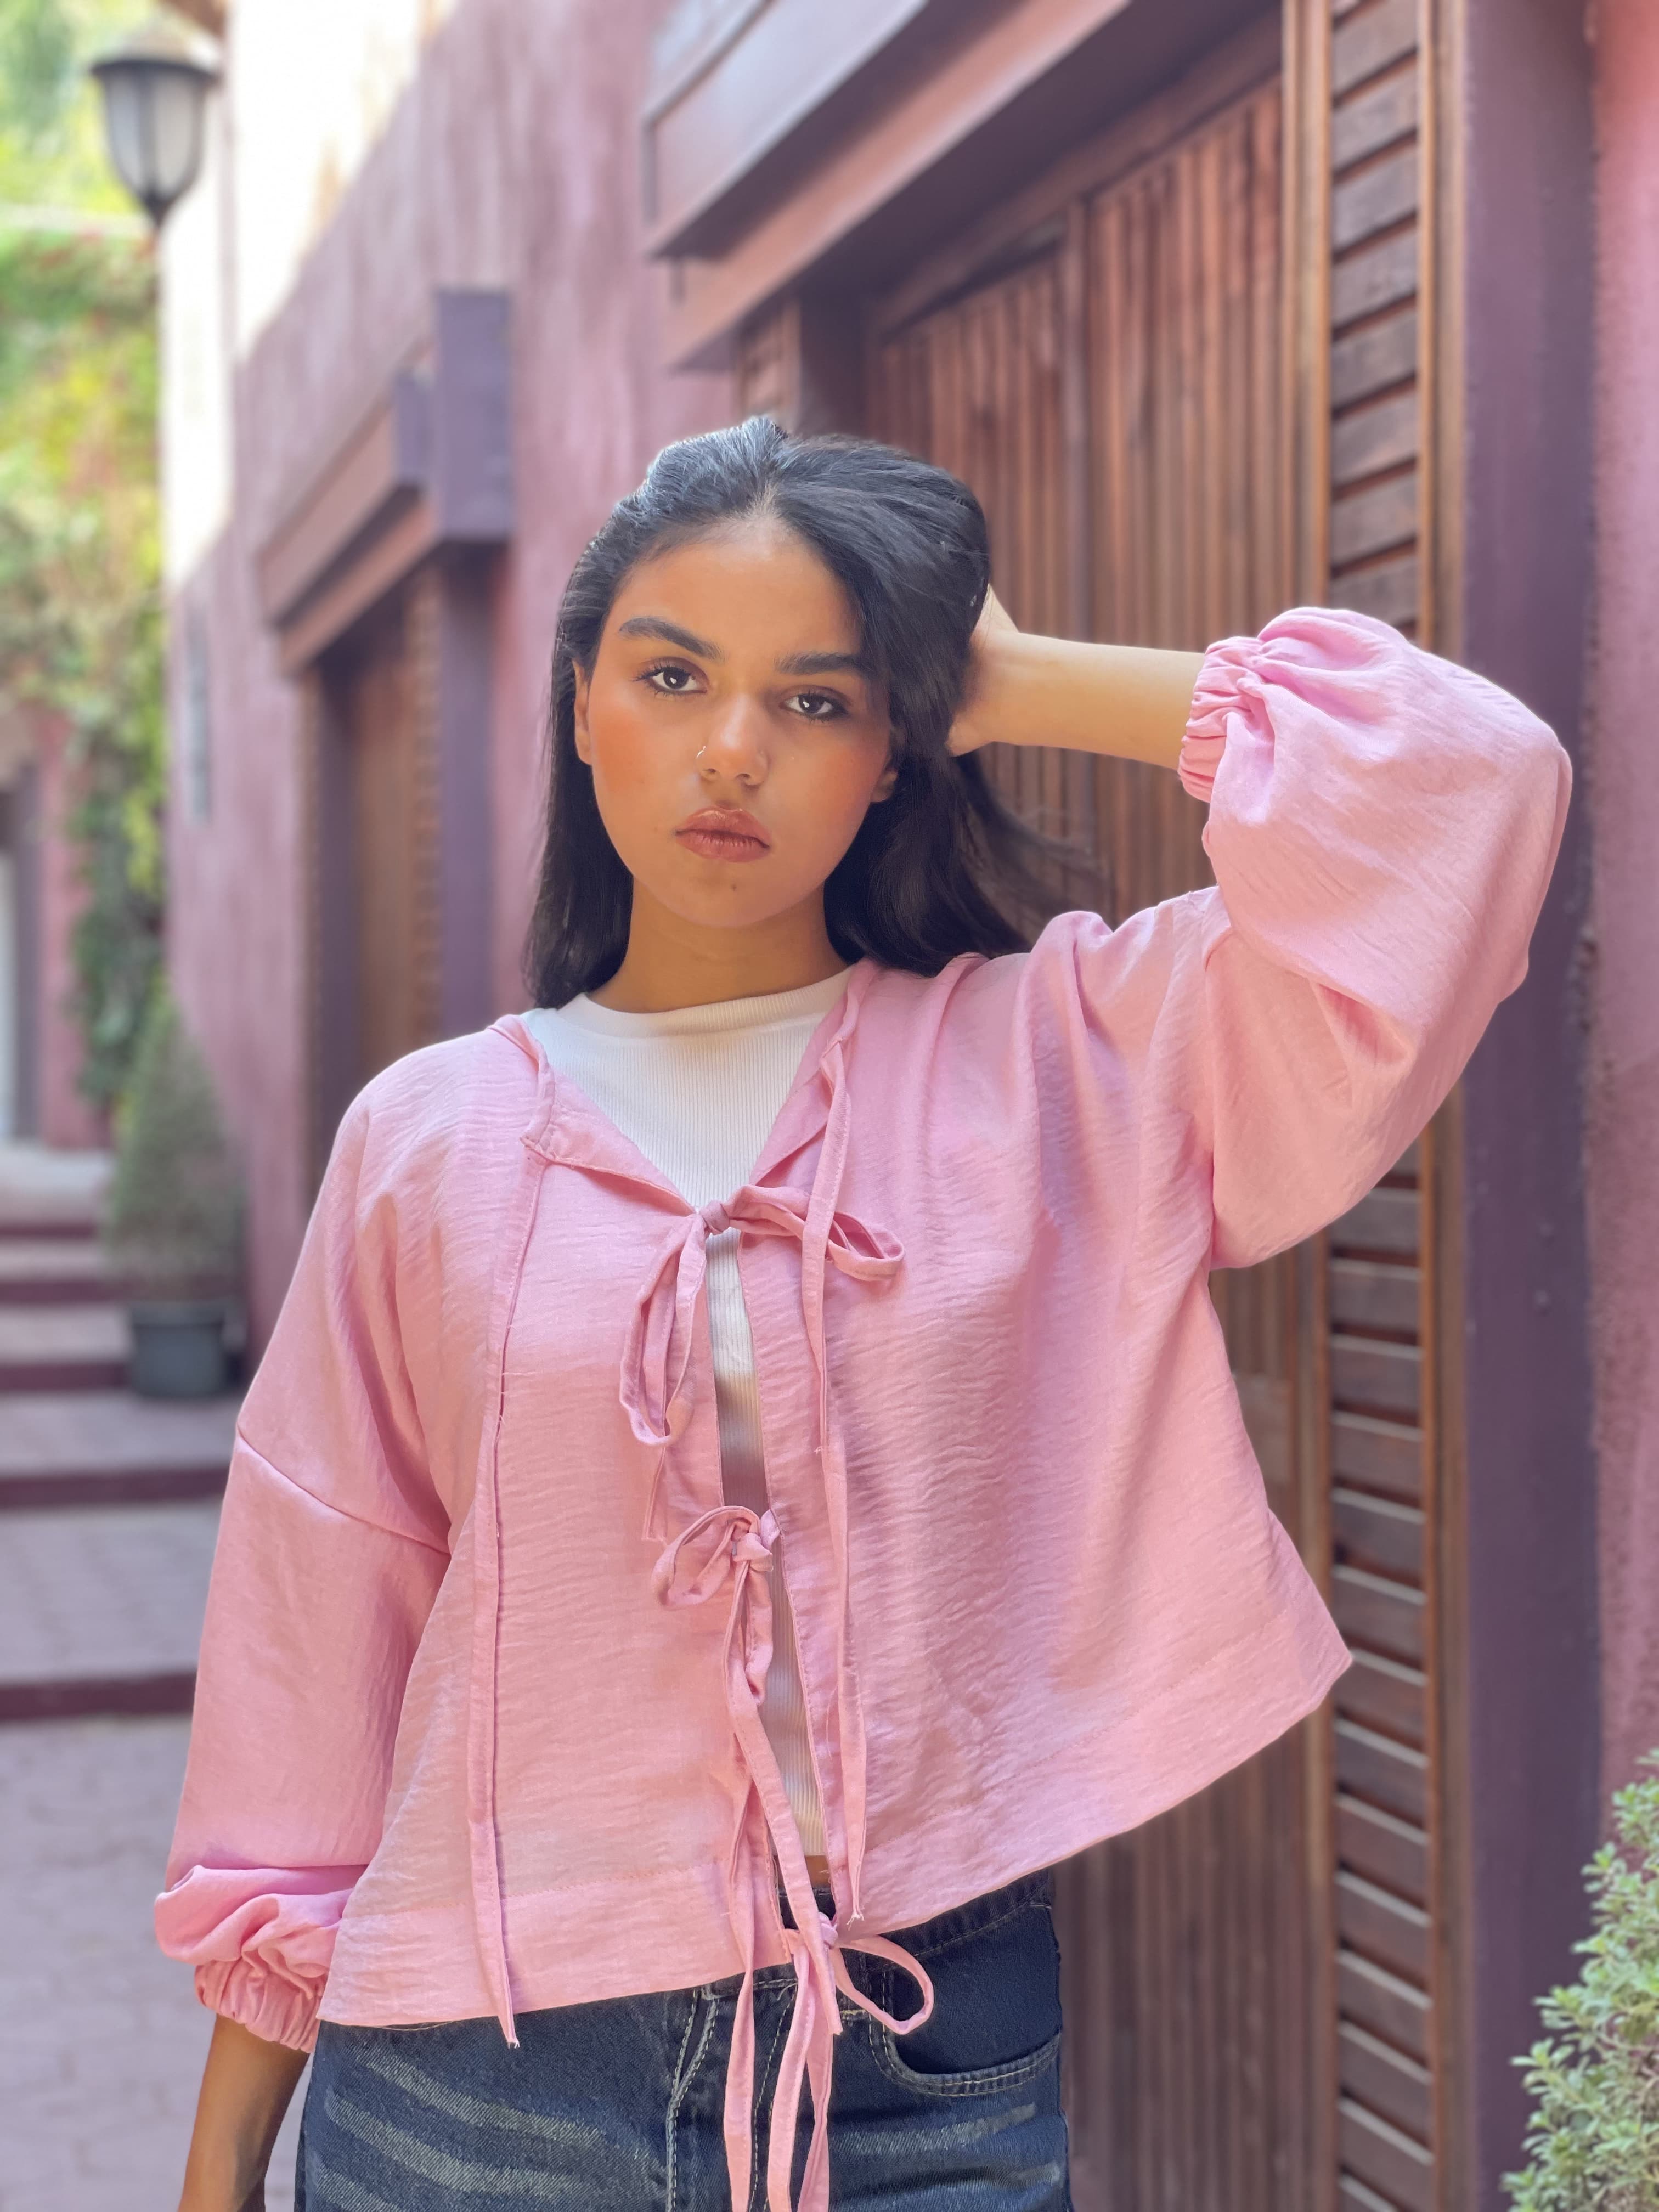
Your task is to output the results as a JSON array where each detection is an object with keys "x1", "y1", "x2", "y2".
[{"x1": 0, "y1": 1500, "x2": 219, "y2": 1721}]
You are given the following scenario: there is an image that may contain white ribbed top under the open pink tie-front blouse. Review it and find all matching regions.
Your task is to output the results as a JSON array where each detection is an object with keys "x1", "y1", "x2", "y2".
[{"x1": 524, "y1": 969, "x2": 849, "y2": 1858}]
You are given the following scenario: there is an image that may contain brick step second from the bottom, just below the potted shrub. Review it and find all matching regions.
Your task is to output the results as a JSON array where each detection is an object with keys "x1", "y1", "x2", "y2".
[{"x1": 0, "y1": 1389, "x2": 241, "y2": 1513}]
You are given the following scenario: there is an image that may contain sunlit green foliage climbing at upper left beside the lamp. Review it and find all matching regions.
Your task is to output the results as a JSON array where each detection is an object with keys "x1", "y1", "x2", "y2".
[{"x1": 0, "y1": 0, "x2": 166, "y2": 1110}]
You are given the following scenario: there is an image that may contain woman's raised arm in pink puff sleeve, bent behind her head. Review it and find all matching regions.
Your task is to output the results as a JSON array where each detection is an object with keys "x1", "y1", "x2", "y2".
[{"x1": 986, "y1": 608, "x2": 1571, "y2": 1267}]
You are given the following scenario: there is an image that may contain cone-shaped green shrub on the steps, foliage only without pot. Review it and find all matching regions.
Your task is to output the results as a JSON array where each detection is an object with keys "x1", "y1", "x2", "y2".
[{"x1": 104, "y1": 989, "x2": 244, "y2": 1299}]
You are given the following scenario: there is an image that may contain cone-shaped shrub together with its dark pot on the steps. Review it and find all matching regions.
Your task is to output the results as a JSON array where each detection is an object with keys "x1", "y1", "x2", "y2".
[{"x1": 104, "y1": 986, "x2": 244, "y2": 1398}]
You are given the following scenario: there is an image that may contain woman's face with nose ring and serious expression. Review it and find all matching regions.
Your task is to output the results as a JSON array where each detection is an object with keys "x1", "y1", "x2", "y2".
[{"x1": 575, "y1": 522, "x2": 894, "y2": 929}]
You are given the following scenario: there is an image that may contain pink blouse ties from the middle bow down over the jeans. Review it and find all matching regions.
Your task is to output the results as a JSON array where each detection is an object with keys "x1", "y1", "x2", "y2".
[{"x1": 650, "y1": 1506, "x2": 934, "y2": 2212}]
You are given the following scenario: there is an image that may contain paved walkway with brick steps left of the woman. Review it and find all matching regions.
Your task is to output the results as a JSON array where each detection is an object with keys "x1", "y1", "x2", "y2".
[{"x1": 0, "y1": 1146, "x2": 309, "y2": 2212}]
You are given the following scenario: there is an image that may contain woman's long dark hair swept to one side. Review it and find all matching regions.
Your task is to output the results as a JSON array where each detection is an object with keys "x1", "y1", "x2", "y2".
[{"x1": 524, "y1": 416, "x2": 1055, "y2": 1007}]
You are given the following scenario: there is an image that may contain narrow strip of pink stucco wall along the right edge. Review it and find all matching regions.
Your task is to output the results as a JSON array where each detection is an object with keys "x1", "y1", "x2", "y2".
[{"x1": 1588, "y1": 0, "x2": 1659, "y2": 1790}]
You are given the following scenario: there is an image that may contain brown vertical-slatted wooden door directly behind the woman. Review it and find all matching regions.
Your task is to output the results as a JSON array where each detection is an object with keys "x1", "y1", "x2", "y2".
[{"x1": 872, "y1": 80, "x2": 1327, "y2": 2212}]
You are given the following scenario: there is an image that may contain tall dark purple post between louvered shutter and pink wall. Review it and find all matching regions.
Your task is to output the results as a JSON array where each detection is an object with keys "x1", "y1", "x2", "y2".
[{"x1": 1434, "y1": 0, "x2": 1601, "y2": 2212}]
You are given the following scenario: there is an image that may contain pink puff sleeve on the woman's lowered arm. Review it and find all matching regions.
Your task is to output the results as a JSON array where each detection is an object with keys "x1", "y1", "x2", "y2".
[{"x1": 155, "y1": 1099, "x2": 449, "y2": 2049}]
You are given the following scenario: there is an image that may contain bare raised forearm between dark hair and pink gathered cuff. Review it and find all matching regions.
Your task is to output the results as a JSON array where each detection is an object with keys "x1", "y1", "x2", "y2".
[{"x1": 960, "y1": 628, "x2": 1203, "y2": 768}]
